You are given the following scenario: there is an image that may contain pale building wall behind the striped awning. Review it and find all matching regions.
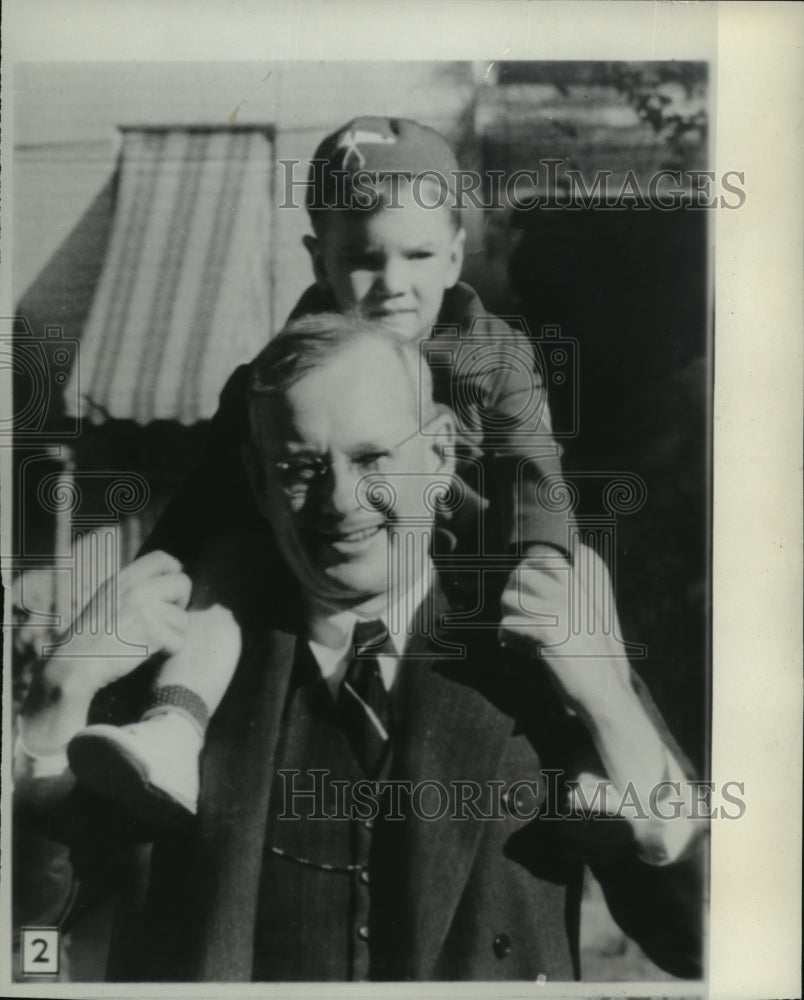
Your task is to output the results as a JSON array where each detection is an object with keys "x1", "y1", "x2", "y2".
[{"x1": 12, "y1": 62, "x2": 475, "y2": 322}]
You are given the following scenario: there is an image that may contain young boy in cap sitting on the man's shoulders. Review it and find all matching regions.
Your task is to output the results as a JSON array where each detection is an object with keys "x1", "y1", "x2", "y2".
[{"x1": 64, "y1": 117, "x2": 571, "y2": 813}]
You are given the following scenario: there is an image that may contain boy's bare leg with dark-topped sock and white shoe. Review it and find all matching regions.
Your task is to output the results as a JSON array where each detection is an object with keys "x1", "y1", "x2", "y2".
[{"x1": 67, "y1": 605, "x2": 241, "y2": 822}]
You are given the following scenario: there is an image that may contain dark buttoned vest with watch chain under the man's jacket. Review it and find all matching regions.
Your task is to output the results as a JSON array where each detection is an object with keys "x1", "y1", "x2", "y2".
[{"x1": 254, "y1": 643, "x2": 404, "y2": 982}]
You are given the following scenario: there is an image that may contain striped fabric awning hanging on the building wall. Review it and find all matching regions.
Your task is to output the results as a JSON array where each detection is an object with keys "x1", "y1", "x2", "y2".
[{"x1": 67, "y1": 128, "x2": 273, "y2": 424}]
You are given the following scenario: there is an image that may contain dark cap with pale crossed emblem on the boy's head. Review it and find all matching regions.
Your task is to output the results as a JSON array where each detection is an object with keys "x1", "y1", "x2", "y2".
[{"x1": 307, "y1": 116, "x2": 458, "y2": 213}]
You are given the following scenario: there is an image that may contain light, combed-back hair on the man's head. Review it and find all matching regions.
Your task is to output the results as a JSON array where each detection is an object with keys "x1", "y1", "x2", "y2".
[{"x1": 248, "y1": 313, "x2": 433, "y2": 440}]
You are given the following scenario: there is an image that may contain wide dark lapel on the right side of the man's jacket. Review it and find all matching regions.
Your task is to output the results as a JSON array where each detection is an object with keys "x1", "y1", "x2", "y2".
[{"x1": 395, "y1": 591, "x2": 513, "y2": 980}]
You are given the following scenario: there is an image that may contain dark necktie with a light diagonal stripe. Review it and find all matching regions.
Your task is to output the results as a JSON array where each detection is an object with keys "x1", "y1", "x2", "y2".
[{"x1": 338, "y1": 621, "x2": 391, "y2": 777}]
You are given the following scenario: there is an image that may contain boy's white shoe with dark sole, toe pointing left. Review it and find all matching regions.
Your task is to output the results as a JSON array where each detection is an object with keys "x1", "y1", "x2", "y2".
[{"x1": 67, "y1": 711, "x2": 203, "y2": 826}]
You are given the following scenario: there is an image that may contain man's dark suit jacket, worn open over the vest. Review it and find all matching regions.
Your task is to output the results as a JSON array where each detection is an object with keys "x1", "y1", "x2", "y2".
[{"x1": 23, "y1": 538, "x2": 701, "y2": 982}]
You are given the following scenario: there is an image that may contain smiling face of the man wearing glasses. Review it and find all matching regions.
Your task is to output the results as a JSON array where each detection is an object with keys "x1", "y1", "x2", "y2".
[{"x1": 251, "y1": 339, "x2": 452, "y2": 605}]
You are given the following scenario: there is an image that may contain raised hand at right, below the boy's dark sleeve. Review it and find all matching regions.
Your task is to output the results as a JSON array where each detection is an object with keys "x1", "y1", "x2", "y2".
[{"x1": 500, "y1": 545, "x2": 629, "y2": 709}]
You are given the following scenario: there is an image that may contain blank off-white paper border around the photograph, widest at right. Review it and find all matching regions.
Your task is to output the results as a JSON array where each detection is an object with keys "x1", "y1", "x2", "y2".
[{"x1": 0, "y1": 0, "x2": 804, "y2": 1000}]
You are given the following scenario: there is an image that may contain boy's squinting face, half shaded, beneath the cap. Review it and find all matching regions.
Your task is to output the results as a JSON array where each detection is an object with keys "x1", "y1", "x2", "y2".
[{"x1": 305, "y1": 183, "x2": 466, "y2": 338}]
